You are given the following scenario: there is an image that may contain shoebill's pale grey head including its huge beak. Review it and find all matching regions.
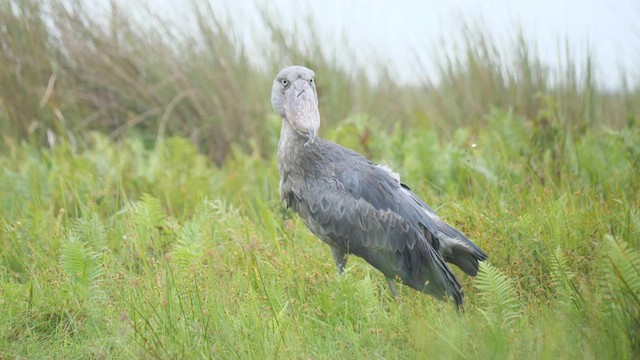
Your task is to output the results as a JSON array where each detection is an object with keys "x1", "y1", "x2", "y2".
[{"x1": 271, "y1": 66, "x2": 320, "y2": 144}]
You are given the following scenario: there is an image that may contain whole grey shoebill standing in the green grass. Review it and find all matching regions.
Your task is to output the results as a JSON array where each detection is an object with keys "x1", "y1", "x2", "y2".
[{"x1": 271, "y1": 65, "x2": 487, "y2": 309}]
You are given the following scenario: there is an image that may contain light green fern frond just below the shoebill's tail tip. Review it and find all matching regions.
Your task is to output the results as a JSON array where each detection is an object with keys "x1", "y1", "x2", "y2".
[{"x1": 475, "y1": 262, "x2": 520, "y2": 326}]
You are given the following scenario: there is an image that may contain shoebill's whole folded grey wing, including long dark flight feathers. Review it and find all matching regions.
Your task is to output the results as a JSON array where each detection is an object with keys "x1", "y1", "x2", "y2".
[{"x1": 298, "y1": 158, "x2": 463, "y2": 304}]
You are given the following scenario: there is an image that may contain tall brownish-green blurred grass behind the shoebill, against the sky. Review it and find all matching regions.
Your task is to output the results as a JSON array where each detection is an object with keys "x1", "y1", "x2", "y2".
[{"x1": 0, "y1": 0, "x2": 640, "y2": 160}]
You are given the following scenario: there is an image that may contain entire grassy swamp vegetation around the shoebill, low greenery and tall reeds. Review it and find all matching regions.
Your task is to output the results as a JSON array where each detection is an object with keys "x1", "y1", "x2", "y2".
[{"x1": 0, "y1": 1, "x2": 640, "y2": 359}]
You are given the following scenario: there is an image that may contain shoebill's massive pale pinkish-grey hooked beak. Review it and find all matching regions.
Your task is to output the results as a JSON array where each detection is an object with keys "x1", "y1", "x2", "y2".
[{"x1": 284, "y1": 79, "x2": 320, "y2": 145}]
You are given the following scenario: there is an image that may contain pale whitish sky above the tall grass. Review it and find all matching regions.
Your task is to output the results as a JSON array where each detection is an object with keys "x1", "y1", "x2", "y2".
[{"x1": 96, "y1": 0, "x2": 640, "y2": 86}]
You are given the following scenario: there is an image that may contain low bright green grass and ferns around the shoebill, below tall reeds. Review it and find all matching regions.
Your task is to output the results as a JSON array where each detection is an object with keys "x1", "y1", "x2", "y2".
[{"x1": 0, "y1": 113, "x2": 640, "y2": 358}]
